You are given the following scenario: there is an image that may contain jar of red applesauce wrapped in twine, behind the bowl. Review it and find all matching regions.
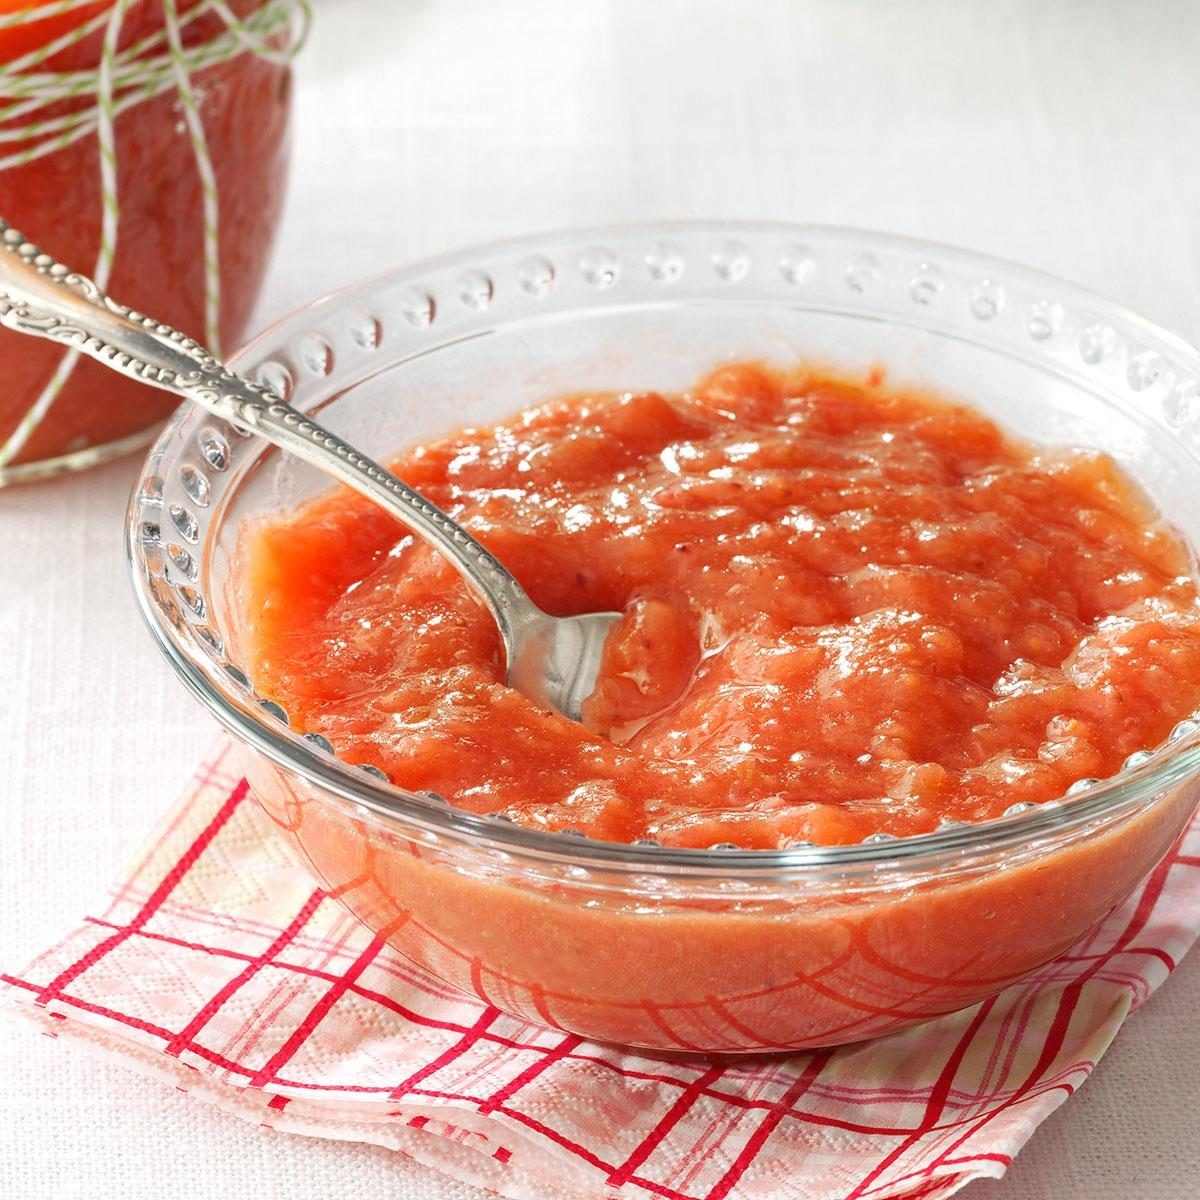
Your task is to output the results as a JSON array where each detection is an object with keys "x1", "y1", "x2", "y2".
[{"x1": 0, "y1": 0, "x2": 308, "y2": 485}]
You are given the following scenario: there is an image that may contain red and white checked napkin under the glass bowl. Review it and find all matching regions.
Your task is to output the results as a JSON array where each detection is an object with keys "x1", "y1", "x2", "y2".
[{"x1": 2, "y1": 743, "x2": 1200, "y2": 1200}]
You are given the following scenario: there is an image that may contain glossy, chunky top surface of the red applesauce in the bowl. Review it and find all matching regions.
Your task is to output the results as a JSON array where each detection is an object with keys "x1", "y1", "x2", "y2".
[{"x1": 241, "y1": 364, "x2": 1200, "y2": 848}]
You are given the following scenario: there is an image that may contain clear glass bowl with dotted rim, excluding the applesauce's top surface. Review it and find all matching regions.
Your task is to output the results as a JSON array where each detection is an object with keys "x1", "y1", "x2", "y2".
[{"x1": 128, "y1": 224, "x2": 1200, "y2": 1054}]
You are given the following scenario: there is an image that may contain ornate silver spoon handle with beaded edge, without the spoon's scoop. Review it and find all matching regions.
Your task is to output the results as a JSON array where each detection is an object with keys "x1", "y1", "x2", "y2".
[{"x1": 0, "y1": 218, "x2": 533, "y2": 650}]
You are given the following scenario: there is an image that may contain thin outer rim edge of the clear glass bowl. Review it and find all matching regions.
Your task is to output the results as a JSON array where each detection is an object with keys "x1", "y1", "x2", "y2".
[{"x1": 126, "y1": 220, "x2": 1200, "y2": 882}]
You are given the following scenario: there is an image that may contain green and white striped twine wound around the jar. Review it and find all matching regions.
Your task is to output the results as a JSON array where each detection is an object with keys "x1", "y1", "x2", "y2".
[{"x1": 0, "y1": 0, "x2": 310, "y2": 470}]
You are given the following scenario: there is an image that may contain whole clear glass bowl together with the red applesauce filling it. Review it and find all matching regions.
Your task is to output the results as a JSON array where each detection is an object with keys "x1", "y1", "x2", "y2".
[{"x1": 128, "y1": 223, "x2": 1200, "y2": 1054}]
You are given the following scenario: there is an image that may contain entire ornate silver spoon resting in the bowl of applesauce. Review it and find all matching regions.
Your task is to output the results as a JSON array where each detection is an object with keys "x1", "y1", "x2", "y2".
[{"x1": 0, "y1": 218, "x2": 622, "y2": 721}]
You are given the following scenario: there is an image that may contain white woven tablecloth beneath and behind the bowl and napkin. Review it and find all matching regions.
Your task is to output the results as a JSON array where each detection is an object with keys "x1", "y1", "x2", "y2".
[{"x1": 0, "y1": 0, "x2": 1200, "y2": 1200}]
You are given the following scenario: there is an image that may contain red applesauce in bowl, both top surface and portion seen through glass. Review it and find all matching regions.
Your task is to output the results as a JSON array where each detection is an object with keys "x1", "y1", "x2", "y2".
[{"x1": 234, "y1": 364, "x2": 1200, "y2": 1054}]
